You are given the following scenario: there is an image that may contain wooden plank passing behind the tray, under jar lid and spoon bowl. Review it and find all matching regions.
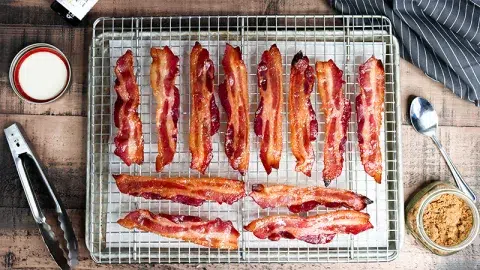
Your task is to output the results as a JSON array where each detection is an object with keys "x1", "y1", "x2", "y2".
[{"x1": 0, "y1": 24, "x2": 480, "y2": 129}]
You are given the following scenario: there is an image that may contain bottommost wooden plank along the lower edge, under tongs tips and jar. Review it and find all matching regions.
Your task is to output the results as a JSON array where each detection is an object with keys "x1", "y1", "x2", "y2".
[{"x1": 0, "y1": 208, "x2": 480, "y2": 270}]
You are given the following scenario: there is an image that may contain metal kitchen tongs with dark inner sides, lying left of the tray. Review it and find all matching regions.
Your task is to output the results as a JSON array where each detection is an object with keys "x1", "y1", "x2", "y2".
[{"x1": 4, "y1": 124, "x2": 78, "y2": 269}]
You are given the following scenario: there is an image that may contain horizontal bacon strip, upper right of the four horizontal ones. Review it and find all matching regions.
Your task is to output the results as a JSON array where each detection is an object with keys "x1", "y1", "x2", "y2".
[{"x1": 250, "y1": 184, "x2": 373, "y2": 213}]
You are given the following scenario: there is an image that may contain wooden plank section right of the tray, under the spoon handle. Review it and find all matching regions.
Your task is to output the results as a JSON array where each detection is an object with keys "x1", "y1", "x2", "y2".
[{"x1": 402, "y1": 125, "x2": 480, "y2": 198}]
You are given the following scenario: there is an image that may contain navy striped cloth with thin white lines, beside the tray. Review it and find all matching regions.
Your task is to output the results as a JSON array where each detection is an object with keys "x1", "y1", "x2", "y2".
[{"x1": 330, "y1": 0, "x2": 480, "y2": 106}]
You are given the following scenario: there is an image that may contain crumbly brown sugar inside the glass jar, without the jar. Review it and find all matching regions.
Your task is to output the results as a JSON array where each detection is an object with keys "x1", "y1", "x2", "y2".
[{"x1": 423, "y1": 194, "x2": 473, "y2": 247}]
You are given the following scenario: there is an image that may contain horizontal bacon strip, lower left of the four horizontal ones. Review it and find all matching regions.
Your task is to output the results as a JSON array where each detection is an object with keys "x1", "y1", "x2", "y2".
[{"x1": 117, "y1": 209, "x2": 240, "y2": 249}]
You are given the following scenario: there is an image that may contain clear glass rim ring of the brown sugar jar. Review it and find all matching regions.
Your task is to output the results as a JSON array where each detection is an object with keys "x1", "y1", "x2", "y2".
[{"x1": 416, "y1": 189, "x2": 480, "y2": 252}]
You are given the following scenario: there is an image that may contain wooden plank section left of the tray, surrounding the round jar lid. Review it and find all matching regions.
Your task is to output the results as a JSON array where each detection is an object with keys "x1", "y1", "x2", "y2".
[{"x1": 0, "y1": 25, "x2": 89, "y2": 116}]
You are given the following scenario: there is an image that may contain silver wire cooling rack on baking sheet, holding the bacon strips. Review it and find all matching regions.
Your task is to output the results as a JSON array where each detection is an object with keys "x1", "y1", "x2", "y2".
[{"x1": 86, "y1": 16, "x2": 404, "y2": 263}]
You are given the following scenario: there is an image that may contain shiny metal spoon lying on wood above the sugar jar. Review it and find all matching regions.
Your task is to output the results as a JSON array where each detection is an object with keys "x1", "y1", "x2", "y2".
[{"x1": 410, "y1": 97, "x2": 477, "y2": 202}]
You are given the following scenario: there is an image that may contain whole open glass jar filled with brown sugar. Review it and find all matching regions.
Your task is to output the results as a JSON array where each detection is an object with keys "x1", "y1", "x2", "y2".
[{"x1": 405, "y1": 181, "x2": 480, "y2": 256}]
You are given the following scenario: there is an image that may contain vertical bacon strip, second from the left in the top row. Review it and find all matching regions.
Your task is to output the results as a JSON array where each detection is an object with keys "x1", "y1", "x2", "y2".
[{"x1": 150, "y1": 46, "x2": 180, "y2": 172}]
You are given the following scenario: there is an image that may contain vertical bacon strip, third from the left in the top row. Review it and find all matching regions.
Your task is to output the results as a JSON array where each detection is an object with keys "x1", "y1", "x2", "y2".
[{"x1": 189, "y1": 42, "x2": 220, "y2": 174}]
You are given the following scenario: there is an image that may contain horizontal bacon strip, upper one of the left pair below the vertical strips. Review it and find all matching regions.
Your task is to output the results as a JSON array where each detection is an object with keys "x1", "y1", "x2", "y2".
[{"x1": 113, "y1": 174, "x2": 245, "y2": 206}]
